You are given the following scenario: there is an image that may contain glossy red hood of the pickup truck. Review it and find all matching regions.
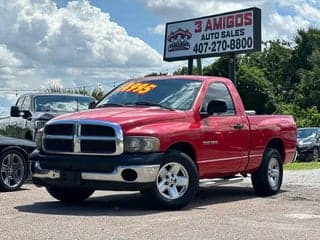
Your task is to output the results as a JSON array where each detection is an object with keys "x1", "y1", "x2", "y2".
[{"x1": 50, "y1": 107, "x2": 186, "y2": 129}]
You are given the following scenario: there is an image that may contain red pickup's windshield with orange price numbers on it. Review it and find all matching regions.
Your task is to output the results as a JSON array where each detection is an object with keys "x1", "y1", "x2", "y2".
[{"x1": 97, "y1": 79, "x2": 201, "y2": 110}]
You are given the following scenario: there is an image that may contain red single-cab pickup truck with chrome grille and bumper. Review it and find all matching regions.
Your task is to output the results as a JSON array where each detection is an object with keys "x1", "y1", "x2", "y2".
[{"x1": 30, "y1": 76, "x2": 296, "y2": 209}]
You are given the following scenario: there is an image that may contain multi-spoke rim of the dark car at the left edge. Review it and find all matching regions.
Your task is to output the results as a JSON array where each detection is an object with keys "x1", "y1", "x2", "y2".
[{"x1": 0, "y1": 153, "x2": 25, "y2": 189}]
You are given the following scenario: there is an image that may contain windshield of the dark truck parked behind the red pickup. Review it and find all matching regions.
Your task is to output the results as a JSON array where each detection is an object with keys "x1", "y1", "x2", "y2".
[{"x1": 34, "y1": 95, "x2": 94, "y2": 113}]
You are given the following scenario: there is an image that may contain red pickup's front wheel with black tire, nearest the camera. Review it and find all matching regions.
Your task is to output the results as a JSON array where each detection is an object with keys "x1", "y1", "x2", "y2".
[{"x1": 141, "y1": 150, "x2": 199, "y2": 210}]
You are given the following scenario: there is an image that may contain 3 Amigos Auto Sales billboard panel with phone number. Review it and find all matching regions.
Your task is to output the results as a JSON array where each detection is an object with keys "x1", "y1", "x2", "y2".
[{"x1": 164, "y1": 8, "x2": 261, "y2": 61}]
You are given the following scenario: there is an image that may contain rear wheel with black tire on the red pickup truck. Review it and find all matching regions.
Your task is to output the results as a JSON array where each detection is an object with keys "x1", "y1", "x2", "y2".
[{"x1": 251, "y1": 148, "x2": 283, "y2": 196}]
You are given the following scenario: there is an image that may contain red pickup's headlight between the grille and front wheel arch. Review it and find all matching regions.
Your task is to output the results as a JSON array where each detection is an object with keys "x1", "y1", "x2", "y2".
[{"x1": 124, "y1": 136, "x2": 160, "y2": 153}]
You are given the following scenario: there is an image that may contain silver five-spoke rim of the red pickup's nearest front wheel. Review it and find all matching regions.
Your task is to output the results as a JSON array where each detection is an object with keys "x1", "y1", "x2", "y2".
[{"x1": 157, "y1": 162, "x2": 189, "y2": 200}]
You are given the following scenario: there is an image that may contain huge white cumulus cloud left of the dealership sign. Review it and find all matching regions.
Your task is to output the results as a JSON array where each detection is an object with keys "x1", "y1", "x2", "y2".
[{"x1": 0, "y1": 0, "x2": 164, "y2": 107}]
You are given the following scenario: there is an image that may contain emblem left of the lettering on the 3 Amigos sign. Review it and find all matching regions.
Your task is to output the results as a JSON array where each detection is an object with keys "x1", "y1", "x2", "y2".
[{"x1": 167, "y1": 28, "x2": 192, "y2": 52}]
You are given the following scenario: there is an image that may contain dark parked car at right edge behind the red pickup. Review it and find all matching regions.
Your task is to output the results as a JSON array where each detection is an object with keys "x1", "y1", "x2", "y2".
[{"x1": 297, "y1": 127, "x2": 320, "y2": 161}]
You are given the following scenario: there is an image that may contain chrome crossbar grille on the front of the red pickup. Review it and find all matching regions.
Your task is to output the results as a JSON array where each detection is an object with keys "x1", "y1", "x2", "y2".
[{"x1": 42, "y1": 120, "x2": 123, "y2": 155}]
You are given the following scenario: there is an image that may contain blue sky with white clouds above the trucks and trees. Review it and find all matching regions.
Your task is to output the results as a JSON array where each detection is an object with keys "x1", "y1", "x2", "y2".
[{"x1": 0, "y1": 0, "x2": 320, "y2": 116}]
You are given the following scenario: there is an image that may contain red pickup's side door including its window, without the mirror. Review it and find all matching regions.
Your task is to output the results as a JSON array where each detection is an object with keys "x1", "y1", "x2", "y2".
[{"x1": 199, "y1": 82, "x2": 249, "y2": 176}]
